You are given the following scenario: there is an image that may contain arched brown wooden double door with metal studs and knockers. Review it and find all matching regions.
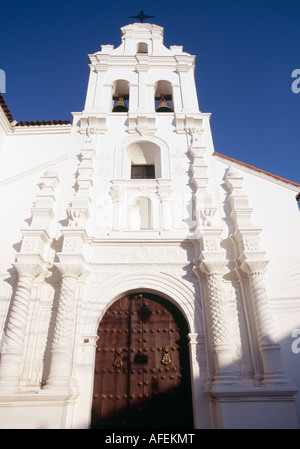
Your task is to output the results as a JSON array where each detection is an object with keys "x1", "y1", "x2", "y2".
[{"x1": 92, "y1": 293, "x2": 193, "y2": 429}]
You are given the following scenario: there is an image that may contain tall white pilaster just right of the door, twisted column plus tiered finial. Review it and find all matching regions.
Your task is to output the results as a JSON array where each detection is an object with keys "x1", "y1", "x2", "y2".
[{"x1": 190, "y1": 128, "x2": 237, "y2": 390}]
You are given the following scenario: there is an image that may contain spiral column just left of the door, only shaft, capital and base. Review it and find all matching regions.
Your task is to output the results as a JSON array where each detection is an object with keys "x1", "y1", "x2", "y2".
[{"x1": 44, "y1": 264, "x2": 81, "y2": 389}]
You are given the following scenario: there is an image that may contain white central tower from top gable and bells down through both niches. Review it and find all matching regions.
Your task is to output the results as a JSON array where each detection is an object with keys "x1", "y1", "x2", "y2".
[{"x1": 80, "y1": 23, "x2": 212, "y2": 237}]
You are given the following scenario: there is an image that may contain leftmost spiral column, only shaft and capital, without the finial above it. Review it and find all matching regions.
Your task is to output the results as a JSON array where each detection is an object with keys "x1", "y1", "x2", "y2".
[{"x1": 0, "y1": 263, "x2": 40, "y2": 392}]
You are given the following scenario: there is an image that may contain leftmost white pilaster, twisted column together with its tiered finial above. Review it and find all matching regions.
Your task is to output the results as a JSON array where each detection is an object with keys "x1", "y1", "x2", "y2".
[{"x1": 0, "y1": 170, "x2": 58, "y2": 394}]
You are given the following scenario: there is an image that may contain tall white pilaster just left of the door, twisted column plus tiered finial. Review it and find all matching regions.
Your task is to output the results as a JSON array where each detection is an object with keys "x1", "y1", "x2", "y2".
[{"x1": 44, "y1": 134, "x2": 96, "y2": 394}]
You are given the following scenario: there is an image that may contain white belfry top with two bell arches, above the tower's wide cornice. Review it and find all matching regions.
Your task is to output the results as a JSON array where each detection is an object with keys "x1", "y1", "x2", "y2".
[{"x1": 84, "y1": 23, "x2": 199, "y2": 115}]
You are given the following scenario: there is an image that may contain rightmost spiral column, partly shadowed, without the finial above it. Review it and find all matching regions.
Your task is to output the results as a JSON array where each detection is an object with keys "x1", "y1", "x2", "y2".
[{"x1": 243, "y1": 262, "x2": 287, "y2": 384}]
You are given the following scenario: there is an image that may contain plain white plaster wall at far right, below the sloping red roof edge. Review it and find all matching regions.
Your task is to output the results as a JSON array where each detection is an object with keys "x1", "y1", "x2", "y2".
[{"x1": 216, "y1": 160, "x2": 300, "y2": 417}]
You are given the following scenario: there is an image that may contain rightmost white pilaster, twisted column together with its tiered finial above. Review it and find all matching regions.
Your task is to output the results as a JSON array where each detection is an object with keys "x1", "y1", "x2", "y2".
[{"x1": 226, "y1": 167, "x2": 288, "y2": 386}]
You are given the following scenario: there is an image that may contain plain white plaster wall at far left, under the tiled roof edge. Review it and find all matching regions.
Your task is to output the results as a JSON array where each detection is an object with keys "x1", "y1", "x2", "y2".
[{"x1": 0, "y1": 129, "x2": 70, "y2": 347}]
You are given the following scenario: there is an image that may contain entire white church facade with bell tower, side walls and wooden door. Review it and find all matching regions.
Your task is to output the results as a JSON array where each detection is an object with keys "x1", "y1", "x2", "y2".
[{"x1": 0, "y1": 23, "x2": 300, "y2": 429}]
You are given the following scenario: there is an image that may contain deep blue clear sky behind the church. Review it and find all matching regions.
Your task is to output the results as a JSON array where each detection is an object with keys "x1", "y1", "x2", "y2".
[{"x1": 0, "y1": 0, "x2": 300, "y2": 183}]
